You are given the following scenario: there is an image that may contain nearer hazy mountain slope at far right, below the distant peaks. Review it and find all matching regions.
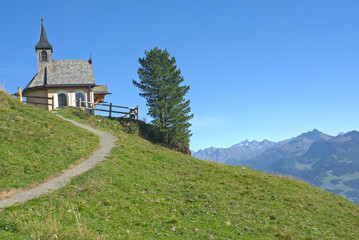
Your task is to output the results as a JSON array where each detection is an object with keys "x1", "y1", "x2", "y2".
[{"x1": 249, "y1": 131, "x2": 359, "y2": 205}]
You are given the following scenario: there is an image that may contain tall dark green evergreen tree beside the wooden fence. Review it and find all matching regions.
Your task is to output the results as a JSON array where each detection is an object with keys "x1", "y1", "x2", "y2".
[{"x1": 133, "y1": 47, "x2": 193, "y2": 154}]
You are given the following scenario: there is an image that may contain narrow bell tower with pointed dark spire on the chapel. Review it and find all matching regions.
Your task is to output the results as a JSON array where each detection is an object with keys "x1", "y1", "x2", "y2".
[{"x1": 35, "y1": 18, "x2": 53, "y2": 72}]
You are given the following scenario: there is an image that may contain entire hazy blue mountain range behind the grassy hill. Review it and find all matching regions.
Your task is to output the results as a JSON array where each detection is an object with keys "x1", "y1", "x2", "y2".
[{"x1": 193, "y1": 129, "x2": 359, "y2": 204}]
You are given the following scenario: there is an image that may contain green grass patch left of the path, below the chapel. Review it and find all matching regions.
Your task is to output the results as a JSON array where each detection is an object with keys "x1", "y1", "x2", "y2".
[{"x1": 0, "y1": 91, "x2": 99, "y2": 196}]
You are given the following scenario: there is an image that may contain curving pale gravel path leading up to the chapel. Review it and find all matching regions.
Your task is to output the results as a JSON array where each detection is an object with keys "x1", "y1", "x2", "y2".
[{"x1": 0, "y1": 114, "x2": 116, "y2": 209}]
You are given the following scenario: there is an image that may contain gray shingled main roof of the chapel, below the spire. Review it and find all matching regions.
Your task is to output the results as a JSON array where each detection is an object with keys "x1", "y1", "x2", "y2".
[{"x1": 24, "y1": 60, "x2": 95, "y2": 92}]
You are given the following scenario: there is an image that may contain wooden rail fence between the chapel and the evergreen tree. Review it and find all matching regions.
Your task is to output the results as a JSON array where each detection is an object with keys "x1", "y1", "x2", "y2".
[{"x1": 76, "y1": 99, "x2": 139, "y2": 120}]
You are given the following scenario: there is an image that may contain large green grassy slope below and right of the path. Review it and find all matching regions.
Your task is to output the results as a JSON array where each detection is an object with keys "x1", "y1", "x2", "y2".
[{"x1": 0, "y1": 109, "x2": 359, "y2": 239}]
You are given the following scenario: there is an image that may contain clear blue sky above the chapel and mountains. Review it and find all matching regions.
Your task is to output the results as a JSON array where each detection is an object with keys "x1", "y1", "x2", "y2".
[{"x1": 0, "y1": 0, "x2": 359, "y2": 150}]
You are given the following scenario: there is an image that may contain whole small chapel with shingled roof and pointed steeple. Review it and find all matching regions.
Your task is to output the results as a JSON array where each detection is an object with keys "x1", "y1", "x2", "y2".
[{"x1": 22, "y1": 19, "x2": 108, "y2": 113}]
